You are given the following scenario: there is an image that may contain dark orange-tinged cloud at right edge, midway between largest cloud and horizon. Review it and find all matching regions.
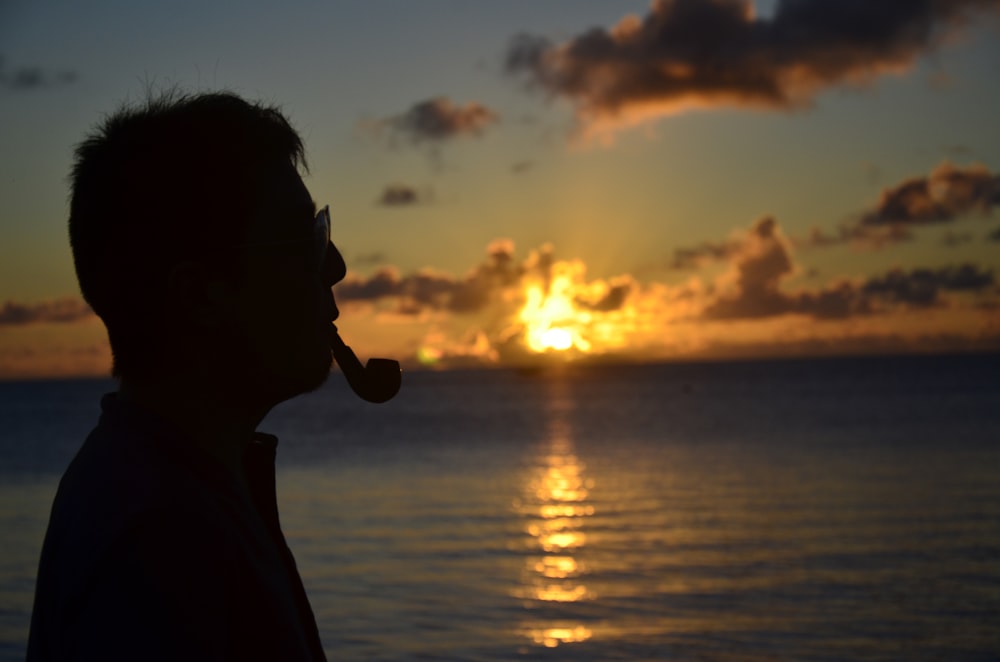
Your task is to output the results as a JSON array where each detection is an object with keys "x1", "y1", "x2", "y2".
[{"x1": 859, "y1": 161, "x2": 1000, "y2": 227}]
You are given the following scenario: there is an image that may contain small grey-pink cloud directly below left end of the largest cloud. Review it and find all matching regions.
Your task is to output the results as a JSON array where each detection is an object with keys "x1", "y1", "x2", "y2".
[{"x1": 379, "y1": 97, "x2": 500, "y2": 144}]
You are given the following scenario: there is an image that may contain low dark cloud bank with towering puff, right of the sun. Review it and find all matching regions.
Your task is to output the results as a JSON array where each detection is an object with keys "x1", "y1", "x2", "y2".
[{"x1": 704, "y1": 217, "x2": 995, "y2": 320}]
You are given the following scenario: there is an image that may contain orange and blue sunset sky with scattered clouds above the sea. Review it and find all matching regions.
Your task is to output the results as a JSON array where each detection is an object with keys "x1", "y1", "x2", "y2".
[{"x1": 0, "y1": 0, "x2": 1000, "y2": 378}]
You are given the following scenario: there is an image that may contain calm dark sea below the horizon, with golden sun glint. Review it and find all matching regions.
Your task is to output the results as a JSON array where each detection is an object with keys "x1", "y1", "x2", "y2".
[{"x1": 0, "y1": 356, "x2": 1000, "y2": 660}]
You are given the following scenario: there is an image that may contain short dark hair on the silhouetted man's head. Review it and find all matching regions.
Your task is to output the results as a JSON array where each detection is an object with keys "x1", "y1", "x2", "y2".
[{"x1": 69, "y1": 90, "x2": 306, "y2": 376}]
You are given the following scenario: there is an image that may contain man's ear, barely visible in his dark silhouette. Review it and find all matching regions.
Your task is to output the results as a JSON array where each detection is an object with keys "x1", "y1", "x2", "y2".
[{"x1": 166, "y1": 262, "x2": 232, "y2": 328}]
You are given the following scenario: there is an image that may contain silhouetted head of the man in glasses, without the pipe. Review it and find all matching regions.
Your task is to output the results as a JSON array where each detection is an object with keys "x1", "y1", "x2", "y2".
[{"x1": 69, "y1": 93, "x2": 344, "y2": 402}]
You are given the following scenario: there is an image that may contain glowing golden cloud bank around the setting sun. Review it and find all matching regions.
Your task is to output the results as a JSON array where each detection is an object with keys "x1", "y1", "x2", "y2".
[{"x1": 334, "y1": 239, "x2": 664, "y2": 366}]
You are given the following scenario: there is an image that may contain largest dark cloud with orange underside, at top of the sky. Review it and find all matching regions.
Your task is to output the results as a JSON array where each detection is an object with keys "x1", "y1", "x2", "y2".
[{"x1": 505, "y1": 0, "x2": 1000, "y2": 136}]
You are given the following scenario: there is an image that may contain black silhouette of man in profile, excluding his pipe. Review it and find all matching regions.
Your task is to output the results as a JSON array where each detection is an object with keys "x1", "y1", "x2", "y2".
[{"x1": 28, "y1": 93, "x2": 345, "y2": 661}]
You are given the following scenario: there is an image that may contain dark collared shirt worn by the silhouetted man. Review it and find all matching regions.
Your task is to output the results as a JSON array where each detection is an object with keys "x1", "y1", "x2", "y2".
[{"x1": 27, "y1": 394, "x2": 324, "y2": 662}]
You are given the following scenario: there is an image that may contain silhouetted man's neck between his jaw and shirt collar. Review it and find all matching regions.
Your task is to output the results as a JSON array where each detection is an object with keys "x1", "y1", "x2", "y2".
[{"x1": 118, "y1": 377, "x2": 267, "y2": 475}]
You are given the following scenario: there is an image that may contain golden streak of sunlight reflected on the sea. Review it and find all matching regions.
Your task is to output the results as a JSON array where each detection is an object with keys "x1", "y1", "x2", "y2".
[{"x1": 518, "y1": 384, "x2": 595, "y2": 648}]
